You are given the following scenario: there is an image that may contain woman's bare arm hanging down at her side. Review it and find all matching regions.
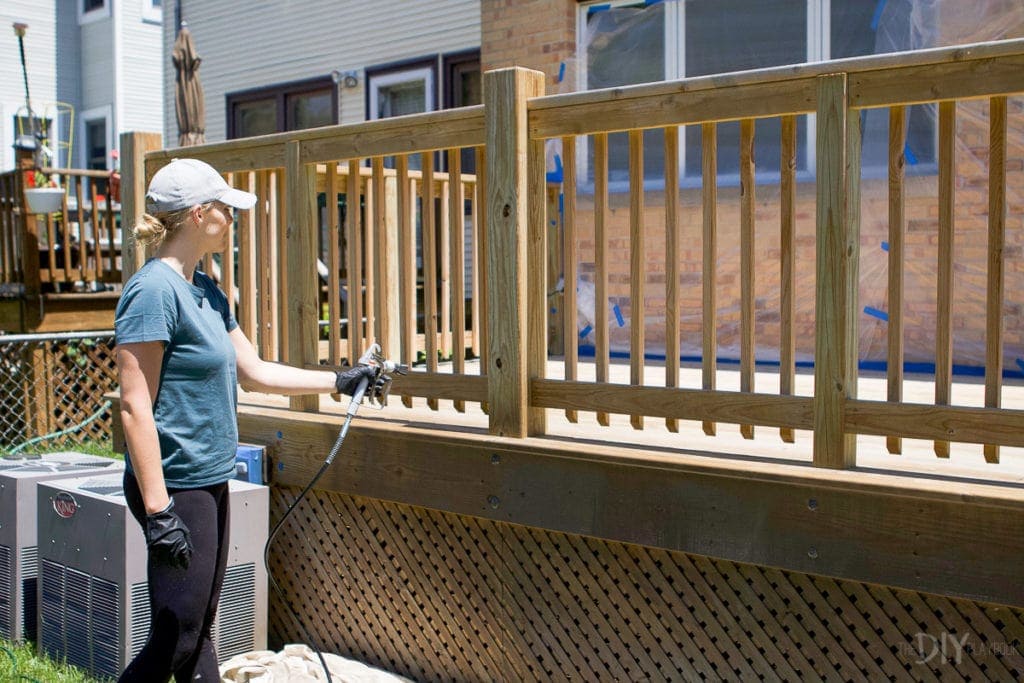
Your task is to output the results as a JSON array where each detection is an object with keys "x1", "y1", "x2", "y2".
[{"x1": 116, "y1": 342, "x2": 170, "y2": 514}]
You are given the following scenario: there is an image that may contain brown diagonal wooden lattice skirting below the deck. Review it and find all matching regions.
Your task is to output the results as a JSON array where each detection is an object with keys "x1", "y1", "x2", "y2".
[{"x1": 269, "y1": 487, "x2": 1024, "y2": 681}]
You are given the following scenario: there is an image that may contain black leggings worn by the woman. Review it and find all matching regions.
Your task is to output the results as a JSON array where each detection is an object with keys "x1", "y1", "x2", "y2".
[{"x1": 118, "y1": 472, "x2": 228, "y2": 683}]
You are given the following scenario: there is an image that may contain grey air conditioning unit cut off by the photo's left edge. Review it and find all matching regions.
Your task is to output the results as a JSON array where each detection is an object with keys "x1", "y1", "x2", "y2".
[{"x1": 0, "y1": 452, "x2": 124, "y2": 641}]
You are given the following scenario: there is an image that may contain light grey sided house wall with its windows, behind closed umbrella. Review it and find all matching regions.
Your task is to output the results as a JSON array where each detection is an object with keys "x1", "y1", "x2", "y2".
[{"x1": 163, "y1": 0, "x2": 480, "y2": 146}]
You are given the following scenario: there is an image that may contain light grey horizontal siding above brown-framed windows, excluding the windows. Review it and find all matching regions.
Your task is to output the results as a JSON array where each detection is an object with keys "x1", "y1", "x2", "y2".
[{"x1": 164, "y1": 0, "x2": 480, "y2": 144}]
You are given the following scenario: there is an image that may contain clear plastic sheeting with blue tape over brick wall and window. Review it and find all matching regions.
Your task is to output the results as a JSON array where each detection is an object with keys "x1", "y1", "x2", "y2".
[{"x1": 561, "y1": 0, "x2": 1024, "y2": 372}]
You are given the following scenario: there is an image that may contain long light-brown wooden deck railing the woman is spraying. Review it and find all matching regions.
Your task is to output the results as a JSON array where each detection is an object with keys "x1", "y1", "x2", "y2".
[{"x1": 123, "y1": 41, "x2": 1024, "y2": 468}]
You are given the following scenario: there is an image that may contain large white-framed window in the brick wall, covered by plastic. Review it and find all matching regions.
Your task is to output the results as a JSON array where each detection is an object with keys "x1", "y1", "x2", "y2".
[{"x1": 578, "y1": 0, "x2": 936, "y2": 182}]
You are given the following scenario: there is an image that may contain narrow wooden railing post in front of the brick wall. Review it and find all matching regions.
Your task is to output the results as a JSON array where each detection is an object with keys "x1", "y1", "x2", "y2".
[{"x1": 814, "y1": 74, "x2": 860, "y2": 469}]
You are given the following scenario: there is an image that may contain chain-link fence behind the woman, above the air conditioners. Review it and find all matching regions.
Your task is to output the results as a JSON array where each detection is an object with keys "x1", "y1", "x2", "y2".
[{"x1": 0, "y1": 332, "x2": 117, "y2": 454}]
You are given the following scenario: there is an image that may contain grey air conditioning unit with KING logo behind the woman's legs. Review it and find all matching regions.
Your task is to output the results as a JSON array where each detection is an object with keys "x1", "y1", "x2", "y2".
[{"x1": 37, "y1": 476, "x2": 269, "y2": 678}]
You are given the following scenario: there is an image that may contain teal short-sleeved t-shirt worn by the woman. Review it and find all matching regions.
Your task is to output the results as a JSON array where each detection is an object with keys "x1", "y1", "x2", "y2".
[{"x1": 114, "y1": 259, "x2": 239, "y2": 488}]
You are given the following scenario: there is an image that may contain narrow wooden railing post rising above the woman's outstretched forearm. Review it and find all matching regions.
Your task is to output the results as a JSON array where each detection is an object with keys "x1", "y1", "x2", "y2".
[{"x1": 282, "y1": 140, "x2": 319, "y2": 413}]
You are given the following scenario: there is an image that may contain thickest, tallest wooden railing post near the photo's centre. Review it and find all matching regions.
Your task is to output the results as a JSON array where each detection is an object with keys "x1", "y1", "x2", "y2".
[{"x1": 483, "y1": 67, "x2": 547, "y2": 437}]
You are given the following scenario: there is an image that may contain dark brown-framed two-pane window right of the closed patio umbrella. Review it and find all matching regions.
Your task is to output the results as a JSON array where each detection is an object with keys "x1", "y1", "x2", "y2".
[{"x1": 226, "y1": 77, "x2": 338, "y2": 139}]
